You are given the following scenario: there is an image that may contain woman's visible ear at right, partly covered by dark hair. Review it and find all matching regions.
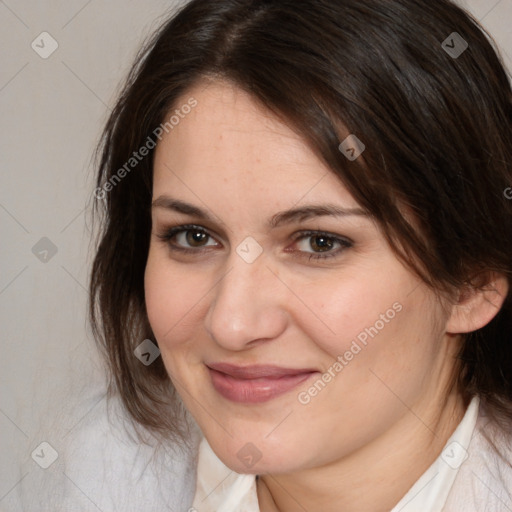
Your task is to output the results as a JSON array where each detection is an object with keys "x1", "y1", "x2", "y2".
[{"x1": 446, "y1": 272, "x2": 509, "y2": 334}]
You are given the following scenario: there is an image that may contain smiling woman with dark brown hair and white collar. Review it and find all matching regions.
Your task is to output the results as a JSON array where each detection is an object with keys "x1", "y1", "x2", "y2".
[{"x1": 91, "y1": 0, "x2": 512, "y2": 512}]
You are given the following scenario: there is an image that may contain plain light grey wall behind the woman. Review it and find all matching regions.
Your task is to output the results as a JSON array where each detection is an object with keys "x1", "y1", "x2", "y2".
[{"x1": 0, "y1": 0, "x2": 512, "y2": 510}]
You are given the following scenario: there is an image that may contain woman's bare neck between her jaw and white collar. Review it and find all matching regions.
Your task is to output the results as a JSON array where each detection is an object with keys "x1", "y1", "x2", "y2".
[{"x1": 257, "y1": 392, "x2": 466, "y2": 512}]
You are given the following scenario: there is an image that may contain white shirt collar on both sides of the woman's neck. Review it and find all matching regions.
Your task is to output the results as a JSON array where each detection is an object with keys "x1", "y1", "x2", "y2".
[{"x1": 193, "y1": 396, "x2": 480, "y2": 512}]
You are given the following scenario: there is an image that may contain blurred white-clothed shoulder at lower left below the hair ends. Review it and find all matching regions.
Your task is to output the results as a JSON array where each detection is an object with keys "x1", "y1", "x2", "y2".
[{"x1": 12, "y1": 393, "x2": 198, "y2": 512}]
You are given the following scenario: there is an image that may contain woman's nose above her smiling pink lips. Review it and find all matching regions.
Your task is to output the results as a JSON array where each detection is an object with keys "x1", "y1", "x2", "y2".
[{"x1": 205, "y1": 249, "x2": 288, "y2": 351}]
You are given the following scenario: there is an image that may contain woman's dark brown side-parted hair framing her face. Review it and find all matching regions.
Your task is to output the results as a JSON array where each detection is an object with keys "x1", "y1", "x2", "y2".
[{"x1": 89, "y1": 0, "x2": 512, "y2": 438}]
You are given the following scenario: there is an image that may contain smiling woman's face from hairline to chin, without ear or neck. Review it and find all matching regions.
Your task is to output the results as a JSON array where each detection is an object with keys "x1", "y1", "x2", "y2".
[{"x1": 145, "y1": 82, "x2": 456, "y2": 474}]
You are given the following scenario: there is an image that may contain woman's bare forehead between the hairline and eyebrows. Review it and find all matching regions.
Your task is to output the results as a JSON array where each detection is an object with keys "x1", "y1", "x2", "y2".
[{"x1": 153, "y1": 82, "x2": 357, "y2": 214}]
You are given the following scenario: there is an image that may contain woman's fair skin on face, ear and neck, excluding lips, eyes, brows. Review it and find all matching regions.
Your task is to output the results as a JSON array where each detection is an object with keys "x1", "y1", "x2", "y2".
[{"x1": 145, "y1": 82, "x2": 508, "y2": 512}]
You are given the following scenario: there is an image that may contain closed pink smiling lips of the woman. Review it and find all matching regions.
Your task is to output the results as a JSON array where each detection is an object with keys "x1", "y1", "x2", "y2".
[{"x1": 207, "y1": 363, "x2": 318, "y2": 403}]
